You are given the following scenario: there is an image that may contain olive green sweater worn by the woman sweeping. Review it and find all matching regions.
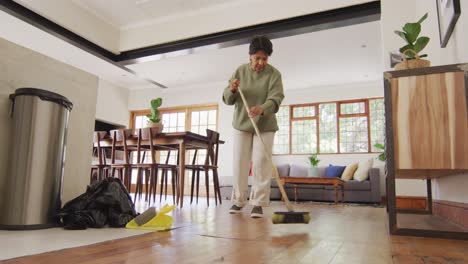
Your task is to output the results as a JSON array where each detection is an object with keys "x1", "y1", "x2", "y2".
[{"x1": 223, "y1": 64, "x2": 284, "y2": 133}]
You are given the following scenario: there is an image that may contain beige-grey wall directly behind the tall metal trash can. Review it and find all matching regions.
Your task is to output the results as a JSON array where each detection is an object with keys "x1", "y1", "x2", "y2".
[{"x1": 0, "y1": 38, "x2": 98, "y2": 202}]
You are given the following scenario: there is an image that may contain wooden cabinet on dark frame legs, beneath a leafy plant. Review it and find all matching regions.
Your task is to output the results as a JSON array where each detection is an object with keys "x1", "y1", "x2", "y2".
[{"x1": 384, "y1": 64, "x2": 468, "y2": 237}]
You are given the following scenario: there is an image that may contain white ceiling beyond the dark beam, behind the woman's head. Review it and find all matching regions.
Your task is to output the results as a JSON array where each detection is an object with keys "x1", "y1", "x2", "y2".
[{"x1": 127, "y1": 21, "x2": 383, "y2": 89}]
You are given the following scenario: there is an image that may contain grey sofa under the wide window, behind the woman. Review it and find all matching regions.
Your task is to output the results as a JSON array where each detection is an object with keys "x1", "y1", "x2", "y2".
[{"x1": 220, "y1": 164, "x2": 381, "y2": 203}]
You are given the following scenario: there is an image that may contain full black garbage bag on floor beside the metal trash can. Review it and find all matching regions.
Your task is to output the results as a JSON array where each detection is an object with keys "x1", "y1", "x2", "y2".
[{"x1": 59, "y1": 178, "x2": 137, "y2": 229}]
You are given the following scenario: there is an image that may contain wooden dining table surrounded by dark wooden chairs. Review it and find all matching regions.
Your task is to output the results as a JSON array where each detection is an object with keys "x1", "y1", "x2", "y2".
[{"x1": 97, "y1": 131, "x2": 224, "y2": 208}]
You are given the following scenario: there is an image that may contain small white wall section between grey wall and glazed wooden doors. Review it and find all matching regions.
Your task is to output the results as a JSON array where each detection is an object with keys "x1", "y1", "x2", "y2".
[{"x1": 96, "y1": 79, "x2": 130, "y2": 127}]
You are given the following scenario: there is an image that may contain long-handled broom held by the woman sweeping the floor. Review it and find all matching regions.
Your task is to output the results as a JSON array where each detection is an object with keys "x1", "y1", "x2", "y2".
[{"x1": 237, "y1": 87, "x2": 310, "y2": 224}]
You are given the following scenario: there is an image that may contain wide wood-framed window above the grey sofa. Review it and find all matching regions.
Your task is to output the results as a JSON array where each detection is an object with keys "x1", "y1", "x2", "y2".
[{"x1": 273, "y1": 98, "x2": 385, "y2": 155}]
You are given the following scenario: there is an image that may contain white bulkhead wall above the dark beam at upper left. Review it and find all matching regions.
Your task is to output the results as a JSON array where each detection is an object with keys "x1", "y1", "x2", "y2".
[{"x1": 16, "y1": 0, "x2": 120, "y2": 54}]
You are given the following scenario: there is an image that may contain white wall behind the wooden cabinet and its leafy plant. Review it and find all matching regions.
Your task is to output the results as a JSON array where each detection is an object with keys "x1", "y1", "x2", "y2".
[{"x1": 381, "y1": 0, "x2": 468, "y2": 203}]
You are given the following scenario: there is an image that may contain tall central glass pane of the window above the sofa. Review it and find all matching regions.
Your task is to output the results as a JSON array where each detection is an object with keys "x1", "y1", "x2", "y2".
[{"x1": 319, "y1": 103, "x2": 338, "y2": 153}]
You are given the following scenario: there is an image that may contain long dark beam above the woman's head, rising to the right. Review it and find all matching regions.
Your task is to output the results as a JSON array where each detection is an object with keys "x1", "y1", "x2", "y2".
[{"x1": 116, "y1": 1, "x2": 380, "y2": 64}]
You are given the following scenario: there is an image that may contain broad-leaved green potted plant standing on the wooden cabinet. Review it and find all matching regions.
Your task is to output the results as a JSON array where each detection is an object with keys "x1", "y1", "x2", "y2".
[{"x1": 395, "y1": 13, "x2": 431, "y2": 70}]
